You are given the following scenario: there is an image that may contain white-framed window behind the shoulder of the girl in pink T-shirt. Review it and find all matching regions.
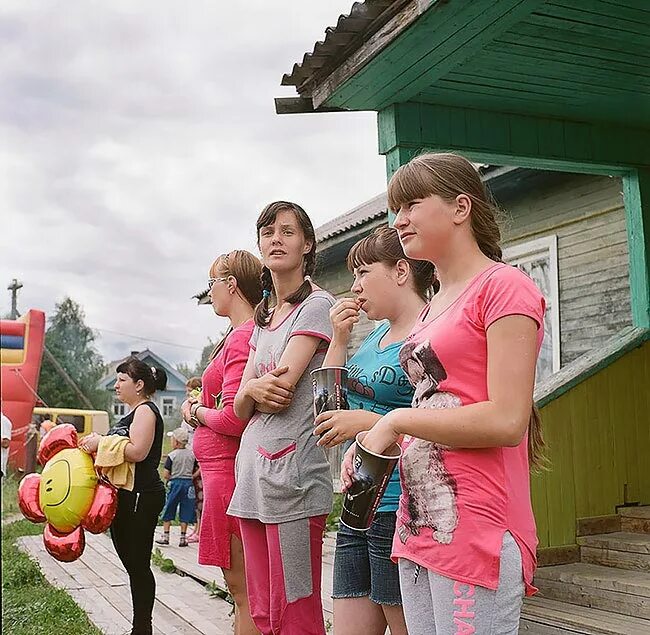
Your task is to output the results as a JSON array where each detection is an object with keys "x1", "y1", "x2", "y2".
[{"x1": 503, "y1": 235, "x2": 560, "y2": 381}]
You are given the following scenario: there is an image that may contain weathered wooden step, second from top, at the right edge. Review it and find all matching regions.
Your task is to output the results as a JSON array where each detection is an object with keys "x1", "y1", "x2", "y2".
[{"x1": 578, "y1": 531, "x2": 650, "y2": 574}]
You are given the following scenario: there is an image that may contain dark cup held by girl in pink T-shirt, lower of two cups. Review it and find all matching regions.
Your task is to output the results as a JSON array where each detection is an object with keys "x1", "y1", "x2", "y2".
[{"x1": 341, "y1": 432, "x2": 402, "y2": 531}]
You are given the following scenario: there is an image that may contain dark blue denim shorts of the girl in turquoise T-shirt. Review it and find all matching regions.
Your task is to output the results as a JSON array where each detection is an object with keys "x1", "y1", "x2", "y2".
[{"x1": 332, "y1": 512, "x2": 402, "y2": 606}]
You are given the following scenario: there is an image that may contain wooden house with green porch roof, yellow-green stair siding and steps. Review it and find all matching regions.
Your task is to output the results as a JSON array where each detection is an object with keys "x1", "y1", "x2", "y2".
[{"x1": 276, "y1": 0, "x2": 650, "y2": 633}]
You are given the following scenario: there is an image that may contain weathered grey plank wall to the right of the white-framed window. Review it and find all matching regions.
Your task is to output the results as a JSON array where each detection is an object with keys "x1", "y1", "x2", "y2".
[{"x1": 499, "y1": 174, "x2": 632, "y2": 365}]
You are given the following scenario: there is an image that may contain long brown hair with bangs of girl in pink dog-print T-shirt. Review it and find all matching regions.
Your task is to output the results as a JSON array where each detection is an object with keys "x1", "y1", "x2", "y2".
[{"x1": 388, "y1": 152, "x2": 546, "y2": 468}]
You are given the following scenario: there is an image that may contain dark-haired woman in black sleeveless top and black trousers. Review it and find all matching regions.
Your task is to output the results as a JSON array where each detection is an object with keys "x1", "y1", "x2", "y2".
[{"x1": 79, "y1": 357, "x2": 167, "y2": 635}]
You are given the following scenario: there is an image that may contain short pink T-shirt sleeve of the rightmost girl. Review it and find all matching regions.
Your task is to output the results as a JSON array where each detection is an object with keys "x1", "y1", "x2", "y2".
[{"x1": 476, "y1": 265, "x2": 546, "y2": 330}]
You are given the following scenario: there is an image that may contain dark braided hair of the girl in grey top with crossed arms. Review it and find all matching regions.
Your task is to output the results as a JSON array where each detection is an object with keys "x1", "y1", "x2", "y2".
[{"x1": 255, "y1": 201, "x2": 316, "y2": 327}]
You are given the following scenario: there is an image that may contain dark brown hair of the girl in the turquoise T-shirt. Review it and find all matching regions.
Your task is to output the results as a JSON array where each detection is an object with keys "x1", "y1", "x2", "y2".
[{"x1": 347, "y1": 225, "x2": 435, "y2": 302}]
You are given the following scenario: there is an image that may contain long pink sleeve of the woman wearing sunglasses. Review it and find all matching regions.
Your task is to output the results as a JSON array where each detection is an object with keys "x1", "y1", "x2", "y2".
[{"x1": 203, "y1": 331, "x2": 250, "y2": 437}]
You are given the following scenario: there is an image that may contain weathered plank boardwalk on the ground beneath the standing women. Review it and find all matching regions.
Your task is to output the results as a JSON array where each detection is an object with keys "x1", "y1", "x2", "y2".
[{"x1": 18, "y1": 527, "x2": 635, "y2": 635}]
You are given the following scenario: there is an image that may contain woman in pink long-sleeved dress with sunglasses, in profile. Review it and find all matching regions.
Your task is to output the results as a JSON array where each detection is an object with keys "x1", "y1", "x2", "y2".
[{"x1": 182, "y1": 251, "x2": 262, "y2": 635}]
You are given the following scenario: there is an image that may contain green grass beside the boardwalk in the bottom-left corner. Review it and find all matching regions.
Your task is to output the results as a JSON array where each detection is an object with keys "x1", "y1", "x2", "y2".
[{"x1": 2, "y1": 520, "x2": 101, "y2": 635}]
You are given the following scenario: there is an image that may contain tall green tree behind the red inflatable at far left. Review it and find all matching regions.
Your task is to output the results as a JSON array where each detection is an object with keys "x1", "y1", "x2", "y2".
[{"x1": 38, "y1": 298, "x2": 111, "y2": 410}]
